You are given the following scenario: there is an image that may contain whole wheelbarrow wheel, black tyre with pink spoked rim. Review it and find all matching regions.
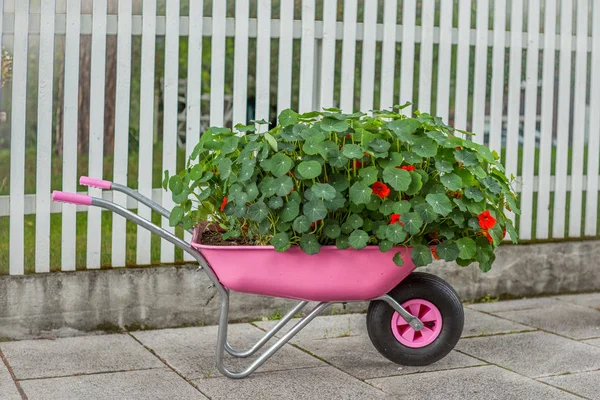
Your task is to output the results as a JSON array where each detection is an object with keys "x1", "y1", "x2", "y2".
[{"x1": 367, "y1": 272, "x2": 464, "y2": 366}]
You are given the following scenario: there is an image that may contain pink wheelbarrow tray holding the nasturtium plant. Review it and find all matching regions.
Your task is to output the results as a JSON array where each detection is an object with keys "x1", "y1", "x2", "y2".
[{"x1": 192, "y1": 231, "x2": 415, "y2": 302}]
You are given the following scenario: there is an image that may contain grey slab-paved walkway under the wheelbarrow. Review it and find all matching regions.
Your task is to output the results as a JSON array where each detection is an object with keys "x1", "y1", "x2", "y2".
[{"x1": 0, "y1": 293, "x2": 600, "y2": 400}]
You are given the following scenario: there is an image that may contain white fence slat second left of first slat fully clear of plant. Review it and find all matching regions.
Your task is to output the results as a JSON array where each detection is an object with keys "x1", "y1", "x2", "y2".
[{"x1": 488, "y1": 0, "x2": 506, "y2": 154}]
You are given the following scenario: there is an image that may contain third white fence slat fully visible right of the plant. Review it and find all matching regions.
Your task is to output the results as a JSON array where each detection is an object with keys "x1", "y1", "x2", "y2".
[{"x1": 552, "y1": 1, "x2": 573, "y2": 238}]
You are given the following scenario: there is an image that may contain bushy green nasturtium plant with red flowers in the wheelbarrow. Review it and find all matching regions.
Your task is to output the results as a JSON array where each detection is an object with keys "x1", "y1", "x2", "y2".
[{"x1": 163, "y1": 106, "x2": 519, "y2": 271}]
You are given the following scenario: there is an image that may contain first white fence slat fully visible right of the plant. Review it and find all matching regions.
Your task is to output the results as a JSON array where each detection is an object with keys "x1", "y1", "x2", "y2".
[{"x1": 519, "y1": 0, "x2": 540, "y2": 240}]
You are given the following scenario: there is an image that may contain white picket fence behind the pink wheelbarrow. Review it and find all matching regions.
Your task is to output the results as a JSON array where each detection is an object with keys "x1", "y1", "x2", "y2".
[{"x1": 0, "y1": 0, "x2": 600, "y2": 275}]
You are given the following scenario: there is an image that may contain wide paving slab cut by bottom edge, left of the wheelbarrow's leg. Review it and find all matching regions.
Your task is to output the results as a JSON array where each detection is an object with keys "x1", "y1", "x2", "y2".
[{"x1": 21, "y1": 368, "x2": 207, "y2": 400}]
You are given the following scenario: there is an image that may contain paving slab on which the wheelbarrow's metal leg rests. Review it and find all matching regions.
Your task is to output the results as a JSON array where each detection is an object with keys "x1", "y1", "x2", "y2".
[{"x1": 133, "y1": 324, "x2": 325, "y2": 379}]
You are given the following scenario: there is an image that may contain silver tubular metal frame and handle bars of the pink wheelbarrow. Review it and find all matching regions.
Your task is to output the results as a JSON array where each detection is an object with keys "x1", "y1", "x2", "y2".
[{"x1": 91, "y1": 195, "x2": 423, "y2": 379}]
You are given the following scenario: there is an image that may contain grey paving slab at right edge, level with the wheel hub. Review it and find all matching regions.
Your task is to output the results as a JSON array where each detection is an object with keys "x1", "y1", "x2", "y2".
[{"x1": 494, "y1": 303, "x2": 600, "y2": 339}]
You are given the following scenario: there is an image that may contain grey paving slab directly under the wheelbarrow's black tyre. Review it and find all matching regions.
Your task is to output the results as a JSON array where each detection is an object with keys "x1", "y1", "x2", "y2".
[{"x1": 290, "y1": 335, "x2": 485, "y2": 379}]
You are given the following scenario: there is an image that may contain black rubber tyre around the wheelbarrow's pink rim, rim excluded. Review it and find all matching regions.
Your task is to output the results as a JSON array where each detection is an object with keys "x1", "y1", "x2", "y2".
[{"x1": 367, "y1": 272, "x2": 465, "y2": 366}]
